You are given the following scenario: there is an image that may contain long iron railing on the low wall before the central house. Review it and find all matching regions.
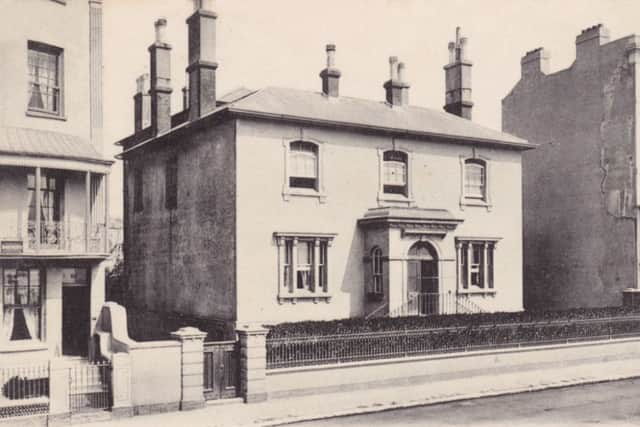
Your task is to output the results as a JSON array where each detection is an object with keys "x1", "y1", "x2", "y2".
[{"x1": 267, "y1": 317, "x2": 640, "y2": 369}]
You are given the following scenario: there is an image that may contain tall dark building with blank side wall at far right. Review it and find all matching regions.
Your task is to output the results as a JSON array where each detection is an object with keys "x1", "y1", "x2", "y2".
[{"x1": 502, "y1": 25, "x2": 640, "y2": 308}]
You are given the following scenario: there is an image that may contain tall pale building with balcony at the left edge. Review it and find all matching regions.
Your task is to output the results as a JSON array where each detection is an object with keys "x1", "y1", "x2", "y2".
[{"x1": 0, "y1": 0, "x2": 113, "y2": 366}]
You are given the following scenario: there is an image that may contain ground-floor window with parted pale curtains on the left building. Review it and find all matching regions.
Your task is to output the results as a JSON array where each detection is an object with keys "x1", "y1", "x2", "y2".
[{"x1": 2, "y1": 268, "x2": 43, "y2": 342}]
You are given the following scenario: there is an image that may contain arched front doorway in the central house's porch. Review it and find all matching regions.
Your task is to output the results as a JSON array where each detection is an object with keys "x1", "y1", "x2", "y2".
[{"x1": 407, "y1": 241, "x2": 440, "y2": 315}]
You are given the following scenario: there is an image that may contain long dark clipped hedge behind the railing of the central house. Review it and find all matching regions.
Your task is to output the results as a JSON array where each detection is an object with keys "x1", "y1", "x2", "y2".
[{"x1": 267, "y1": 307, "x2": 640, "y2": 338}]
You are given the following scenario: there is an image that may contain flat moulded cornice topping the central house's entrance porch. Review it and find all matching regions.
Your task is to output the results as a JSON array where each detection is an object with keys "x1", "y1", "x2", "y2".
[{"x1": 358, "y1": 206, "x2": 464, "y2": 236}]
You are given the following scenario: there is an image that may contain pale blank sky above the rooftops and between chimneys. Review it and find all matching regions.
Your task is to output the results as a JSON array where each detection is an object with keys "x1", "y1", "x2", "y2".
[{"x1": 103, "y1": 0, "x2": 640, "y2": 217}]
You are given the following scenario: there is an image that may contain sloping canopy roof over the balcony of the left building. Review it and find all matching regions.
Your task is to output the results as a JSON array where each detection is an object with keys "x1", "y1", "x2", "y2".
[{"x1": 0, "y1": 127, "x2": 112, "y2": 164}]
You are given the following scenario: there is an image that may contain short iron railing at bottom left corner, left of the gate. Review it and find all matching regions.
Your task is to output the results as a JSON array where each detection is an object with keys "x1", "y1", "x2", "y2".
[{"x1": 0, "y1": 363, "x2": 49, "y2": 419}]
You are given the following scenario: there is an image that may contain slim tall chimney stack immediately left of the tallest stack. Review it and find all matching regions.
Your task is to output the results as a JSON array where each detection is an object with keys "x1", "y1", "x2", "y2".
[{"x1": 149, "y1": 18, "x2": 172, "y2": 136}]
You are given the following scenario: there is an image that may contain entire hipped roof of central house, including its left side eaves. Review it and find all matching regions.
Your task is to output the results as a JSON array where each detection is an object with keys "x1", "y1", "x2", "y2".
[{"x1": 116, "y1": 87, "x2": 535, "y2": 157}]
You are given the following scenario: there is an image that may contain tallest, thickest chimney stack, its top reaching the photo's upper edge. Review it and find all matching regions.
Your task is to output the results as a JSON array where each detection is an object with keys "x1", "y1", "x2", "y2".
[{"x1": 187, "y1": 0, "x2": 218, "y2": 120}]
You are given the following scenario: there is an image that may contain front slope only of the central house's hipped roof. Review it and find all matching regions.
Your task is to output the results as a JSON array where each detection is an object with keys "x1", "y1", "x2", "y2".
[{"x1": 228, "y1": 87, "x2": 531, "y2": 148}]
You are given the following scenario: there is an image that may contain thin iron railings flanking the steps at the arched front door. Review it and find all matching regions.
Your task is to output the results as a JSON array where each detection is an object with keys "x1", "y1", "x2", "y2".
[{"x1": 389, "y1": 292, "x2": 483, "y2": 317}]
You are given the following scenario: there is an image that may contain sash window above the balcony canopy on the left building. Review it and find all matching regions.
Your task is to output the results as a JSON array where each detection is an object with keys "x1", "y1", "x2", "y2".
[{"x1": 28, "y1": 41, "x2": 62, "y2": 116}]
